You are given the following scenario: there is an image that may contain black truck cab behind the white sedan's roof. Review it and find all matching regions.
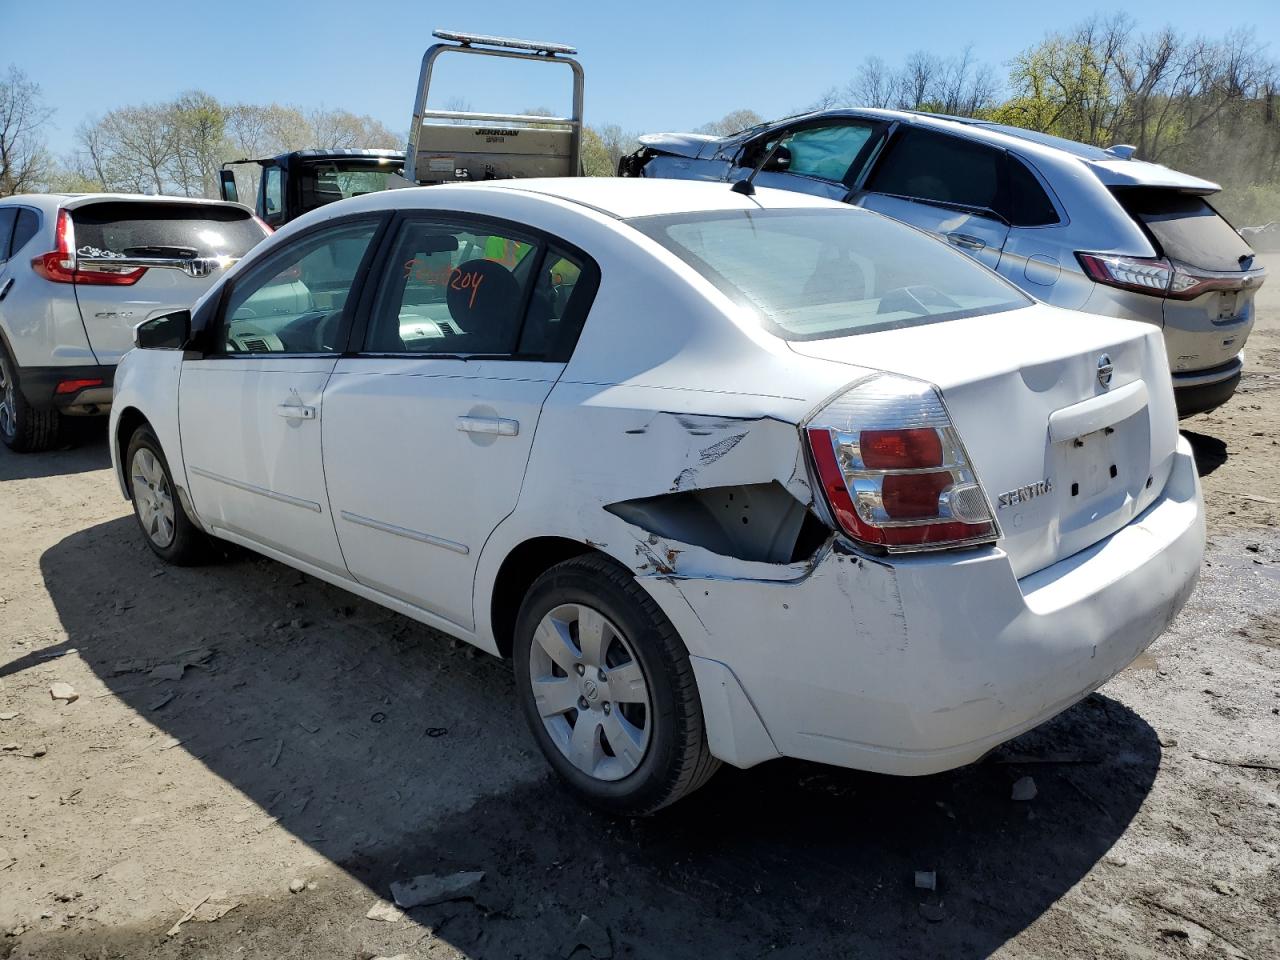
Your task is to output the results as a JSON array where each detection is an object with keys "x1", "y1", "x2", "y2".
[{"x1": 219, "y1": 150, "x2": 404, "y2": 229}]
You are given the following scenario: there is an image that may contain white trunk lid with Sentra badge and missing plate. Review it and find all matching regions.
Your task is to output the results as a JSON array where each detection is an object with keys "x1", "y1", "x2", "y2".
[{"x1": 790, "y1": 305, "x2": 1178, "y2": 577}]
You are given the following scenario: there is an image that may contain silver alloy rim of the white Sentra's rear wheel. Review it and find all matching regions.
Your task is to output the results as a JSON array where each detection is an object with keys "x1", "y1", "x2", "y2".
[{"x1": 529, "y1": 603, "x2": 653, "y2": 781}]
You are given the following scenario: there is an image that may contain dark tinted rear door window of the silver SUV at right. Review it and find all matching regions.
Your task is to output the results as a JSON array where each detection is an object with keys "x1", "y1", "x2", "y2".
[{"x1": 867, "y1": 127, "x2": 1005, "y2": 210}]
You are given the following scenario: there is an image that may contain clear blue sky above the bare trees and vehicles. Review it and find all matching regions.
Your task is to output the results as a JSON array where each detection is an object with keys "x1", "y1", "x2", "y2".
[{"x1": 0, "y1": 0, "x2": 1280, "y2": 152}]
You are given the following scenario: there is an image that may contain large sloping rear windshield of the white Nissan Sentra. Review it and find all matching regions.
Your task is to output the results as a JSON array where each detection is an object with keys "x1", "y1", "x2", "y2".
[{"x1": 630, "y1": 210, "x2": 1032, "y2": 340}]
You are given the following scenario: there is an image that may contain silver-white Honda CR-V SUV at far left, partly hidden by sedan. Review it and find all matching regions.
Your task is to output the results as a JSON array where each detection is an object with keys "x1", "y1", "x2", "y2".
[{"x1": 0, "y1": 193, "x2": 270, "y2": 452}]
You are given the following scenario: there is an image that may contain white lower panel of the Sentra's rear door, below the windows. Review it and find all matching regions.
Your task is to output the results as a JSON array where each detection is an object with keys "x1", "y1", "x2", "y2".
[{"x1": 323, "y1": 357, "x2": 563, "y2": 630}]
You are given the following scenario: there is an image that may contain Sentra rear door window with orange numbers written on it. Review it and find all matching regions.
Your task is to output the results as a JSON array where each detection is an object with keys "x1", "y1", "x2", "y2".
[{"x1": 365, "y1": 220, "x2": 544, "y2": 355}]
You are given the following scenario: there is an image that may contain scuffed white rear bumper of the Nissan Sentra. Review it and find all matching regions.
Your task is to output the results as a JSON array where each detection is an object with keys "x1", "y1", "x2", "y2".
[{"x1": 641, "y1": 439, "x2": 1204, "y2": 774}]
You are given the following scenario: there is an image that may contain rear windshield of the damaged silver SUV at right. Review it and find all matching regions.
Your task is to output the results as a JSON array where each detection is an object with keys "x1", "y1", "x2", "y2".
[{"x1": 1115, "y1": 187, "x2": 1253, "y2": 270}]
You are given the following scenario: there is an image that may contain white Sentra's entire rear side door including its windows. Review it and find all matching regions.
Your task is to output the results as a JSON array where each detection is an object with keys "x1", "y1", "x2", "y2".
[{"x1": 323, "y1": 214, "x2": 599, "y2": 630}]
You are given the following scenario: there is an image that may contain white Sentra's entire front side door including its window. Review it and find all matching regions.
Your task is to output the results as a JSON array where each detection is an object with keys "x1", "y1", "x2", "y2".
[{"x1": 178, "y1": 216, "x2": 383, "y2": 577}]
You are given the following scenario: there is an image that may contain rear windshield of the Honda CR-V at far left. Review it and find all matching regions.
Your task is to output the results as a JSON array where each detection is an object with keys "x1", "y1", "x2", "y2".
[{"x1": 72, "y1": 201, "x2": 266, "y2": 257}]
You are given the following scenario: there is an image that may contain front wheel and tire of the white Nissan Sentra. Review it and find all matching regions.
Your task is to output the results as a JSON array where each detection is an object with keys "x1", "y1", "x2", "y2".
[{"x1": 124, "y1": 426, "x2": 212, "y2": 567}]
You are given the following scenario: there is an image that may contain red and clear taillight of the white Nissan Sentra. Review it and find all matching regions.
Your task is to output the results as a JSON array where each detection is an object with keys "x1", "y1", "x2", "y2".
[{"x1": 805, "y1": 374, "x2": 1000, "y2": 552}]
